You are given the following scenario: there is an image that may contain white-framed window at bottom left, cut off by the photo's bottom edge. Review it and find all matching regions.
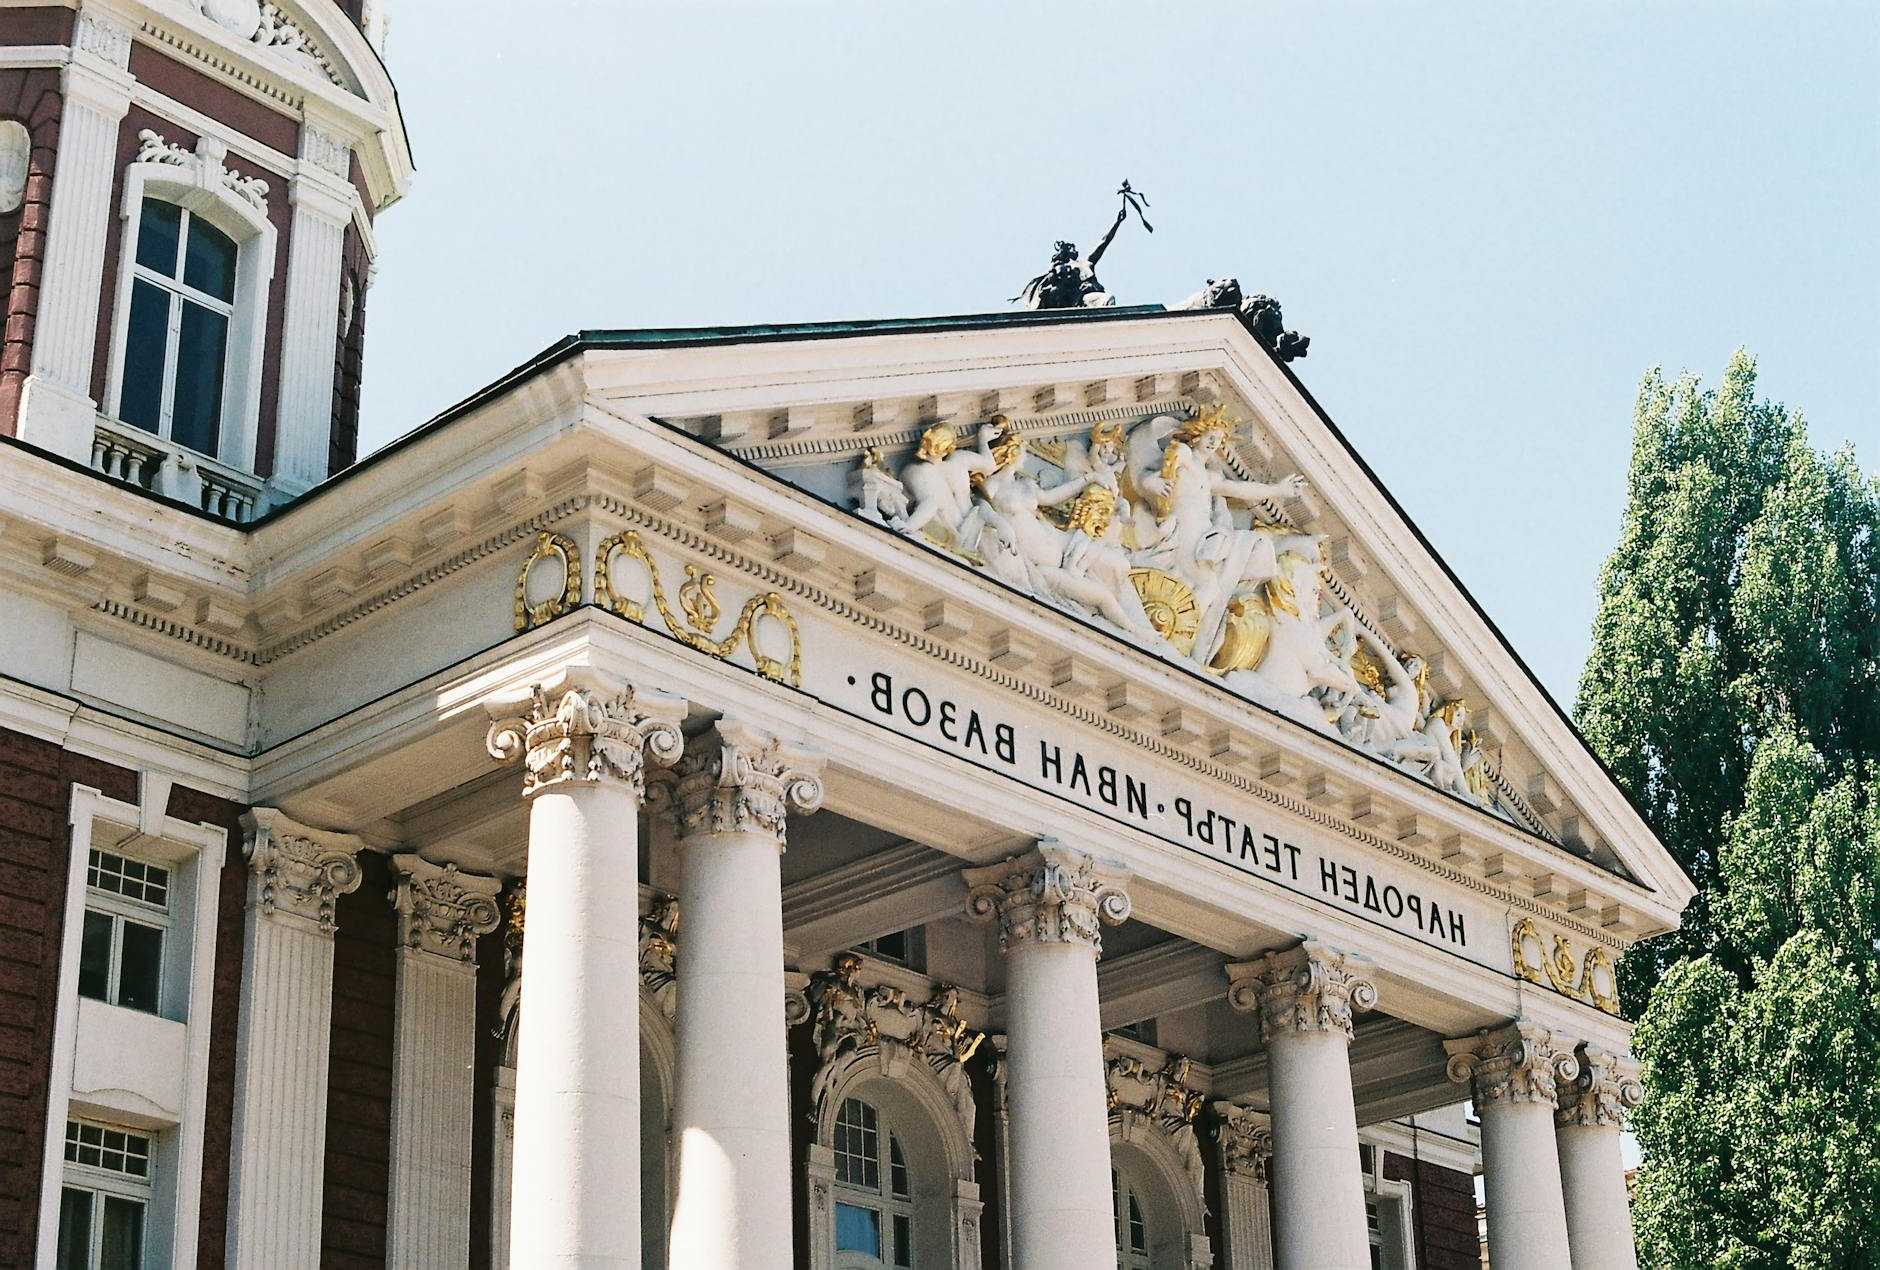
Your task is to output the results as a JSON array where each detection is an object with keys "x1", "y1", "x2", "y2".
[{"x1": 55, "y1": 1120, "x2": 152, "y2": 1270}]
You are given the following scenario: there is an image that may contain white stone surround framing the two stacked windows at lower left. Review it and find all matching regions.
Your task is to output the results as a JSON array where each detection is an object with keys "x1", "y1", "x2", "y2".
[{"x1": 36, "y1": 768, "x2": 227, "y2": 1266}]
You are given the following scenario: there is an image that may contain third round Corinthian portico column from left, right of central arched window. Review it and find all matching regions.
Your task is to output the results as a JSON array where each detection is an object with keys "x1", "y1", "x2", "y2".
[{"x1": 964, "y1": 840, "x2": 1130, "y2": 1270}]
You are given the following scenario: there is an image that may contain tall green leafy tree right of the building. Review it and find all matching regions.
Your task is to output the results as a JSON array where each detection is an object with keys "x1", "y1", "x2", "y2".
[{"x1": 1577, "y1": 351, "x2": 1880, "y2": 1270}]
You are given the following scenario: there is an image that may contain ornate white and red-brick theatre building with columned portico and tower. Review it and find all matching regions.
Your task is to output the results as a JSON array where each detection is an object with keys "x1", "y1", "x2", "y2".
[{"x1": 0, "y1": 0, "x2": 1690, "y2": 1270}]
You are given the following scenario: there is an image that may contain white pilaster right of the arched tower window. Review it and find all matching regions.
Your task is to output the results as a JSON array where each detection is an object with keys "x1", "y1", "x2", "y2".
[{"x1": 273, "y1": 124, "x2": 352, "y2": 498}]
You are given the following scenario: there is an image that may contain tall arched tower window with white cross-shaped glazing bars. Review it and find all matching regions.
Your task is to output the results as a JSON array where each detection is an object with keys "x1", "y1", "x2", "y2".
[{"x1": 118, "y1": 199, "x2": 237, "y2": 455}]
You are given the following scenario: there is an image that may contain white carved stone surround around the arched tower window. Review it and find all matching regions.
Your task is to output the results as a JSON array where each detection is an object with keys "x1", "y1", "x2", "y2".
[{"x1": 98, "y1": 133, "x2": 276, "y2": 473}]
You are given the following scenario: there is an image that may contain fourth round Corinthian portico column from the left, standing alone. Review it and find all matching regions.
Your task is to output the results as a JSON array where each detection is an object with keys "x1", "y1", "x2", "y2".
[{"x1": 1228, "y1": 939, "x2": 1378, "y2": 1270}]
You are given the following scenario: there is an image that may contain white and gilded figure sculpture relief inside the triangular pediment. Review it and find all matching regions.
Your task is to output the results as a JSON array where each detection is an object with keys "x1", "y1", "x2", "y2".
[{"x1": 850, "y1": 406, "x2": 1502, "y2": 812}]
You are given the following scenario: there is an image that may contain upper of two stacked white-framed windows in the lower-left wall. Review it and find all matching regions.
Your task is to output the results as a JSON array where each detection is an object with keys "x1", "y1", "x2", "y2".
[{"x1": 79, "y1": 847, "x2": 171, "y2": 1014}]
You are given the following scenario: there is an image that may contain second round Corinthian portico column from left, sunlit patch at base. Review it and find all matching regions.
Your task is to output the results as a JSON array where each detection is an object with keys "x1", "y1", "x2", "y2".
[{"x1": 671, "y1": 718, "x2": 822, "y2": 1268}]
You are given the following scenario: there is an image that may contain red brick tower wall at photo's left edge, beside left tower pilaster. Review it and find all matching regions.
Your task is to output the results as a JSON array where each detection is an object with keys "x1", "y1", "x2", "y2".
[{"x1": 0, "y1": 67, "x2": 71, "y2": 436}]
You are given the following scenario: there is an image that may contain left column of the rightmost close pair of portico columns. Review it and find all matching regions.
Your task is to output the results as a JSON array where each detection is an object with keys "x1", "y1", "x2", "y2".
[{"x1": 1442, "y1": 1020, "x2": 1579, "y2": 1270}]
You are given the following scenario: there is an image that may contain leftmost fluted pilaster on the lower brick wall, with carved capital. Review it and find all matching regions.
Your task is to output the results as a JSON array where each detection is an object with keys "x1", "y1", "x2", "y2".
[{"x1": 229, "y1": 808, "x2": 361, "y2": 1268}]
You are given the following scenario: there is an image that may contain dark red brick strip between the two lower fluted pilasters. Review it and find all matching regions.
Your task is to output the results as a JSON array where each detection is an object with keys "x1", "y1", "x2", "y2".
[{"x1": 320, "y1": 853, "x2": 397, "y2": 1270}]
